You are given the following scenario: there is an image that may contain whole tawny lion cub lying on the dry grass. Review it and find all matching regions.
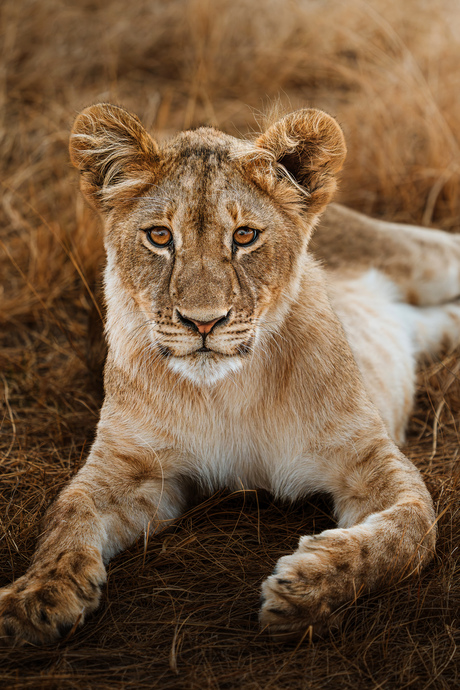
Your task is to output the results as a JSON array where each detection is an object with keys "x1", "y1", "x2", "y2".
[{"x1": 0, "y1": 104, "x2": 460, "y2": 642}]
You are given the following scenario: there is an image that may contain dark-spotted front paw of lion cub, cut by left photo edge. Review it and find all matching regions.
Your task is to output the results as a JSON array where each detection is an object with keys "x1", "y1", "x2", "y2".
[{"x1": 0, "y1": 551, "x2": 106, "y2": 646}]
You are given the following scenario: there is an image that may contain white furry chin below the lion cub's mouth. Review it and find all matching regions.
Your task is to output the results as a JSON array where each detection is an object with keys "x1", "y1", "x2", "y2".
[{"x1": 168, "y1": 352, "x2": 243, "y2": 386}]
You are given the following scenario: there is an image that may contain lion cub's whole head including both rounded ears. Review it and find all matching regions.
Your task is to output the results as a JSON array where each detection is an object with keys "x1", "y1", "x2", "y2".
[{"x1": 70, "y1": 104, "x2": 346, "y2": 383}]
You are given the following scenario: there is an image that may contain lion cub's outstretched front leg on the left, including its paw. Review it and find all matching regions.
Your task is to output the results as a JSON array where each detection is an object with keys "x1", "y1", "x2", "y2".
[{"x1": 0, "y1": 439, "x2": 182, "y2": 644}]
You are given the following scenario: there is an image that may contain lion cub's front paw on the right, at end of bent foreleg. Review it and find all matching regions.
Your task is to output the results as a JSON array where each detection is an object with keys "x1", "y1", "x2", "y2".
[{"x1": 260, "y1": 529, "x2": 354, "y2": 639}]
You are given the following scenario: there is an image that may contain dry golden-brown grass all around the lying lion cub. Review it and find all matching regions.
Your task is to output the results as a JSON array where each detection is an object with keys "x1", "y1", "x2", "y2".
[{"x1": 0, "y1": 0, "x2": 460, "y2": 690}]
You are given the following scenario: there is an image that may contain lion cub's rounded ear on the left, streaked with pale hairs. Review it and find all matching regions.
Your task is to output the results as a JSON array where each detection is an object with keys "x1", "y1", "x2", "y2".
[{"x1": 70, "y1": 103, "x2": 159, "y2": 212}]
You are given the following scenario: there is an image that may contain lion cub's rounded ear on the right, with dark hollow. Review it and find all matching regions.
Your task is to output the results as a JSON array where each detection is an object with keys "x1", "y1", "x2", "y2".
[{"x1": 255, "y1": 108, "x2": 347, "y2": 213}]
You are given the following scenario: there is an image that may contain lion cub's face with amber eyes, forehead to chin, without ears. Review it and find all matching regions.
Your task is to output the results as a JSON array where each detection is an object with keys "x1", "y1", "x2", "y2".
[{"x1": 107, "y1": 129, "x2": 307, "y2": 382}]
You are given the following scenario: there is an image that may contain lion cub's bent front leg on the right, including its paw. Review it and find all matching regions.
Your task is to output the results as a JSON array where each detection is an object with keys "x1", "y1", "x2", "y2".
[{"x1": 260, "y1": 441, "x2": 435, "y2": 636}]
